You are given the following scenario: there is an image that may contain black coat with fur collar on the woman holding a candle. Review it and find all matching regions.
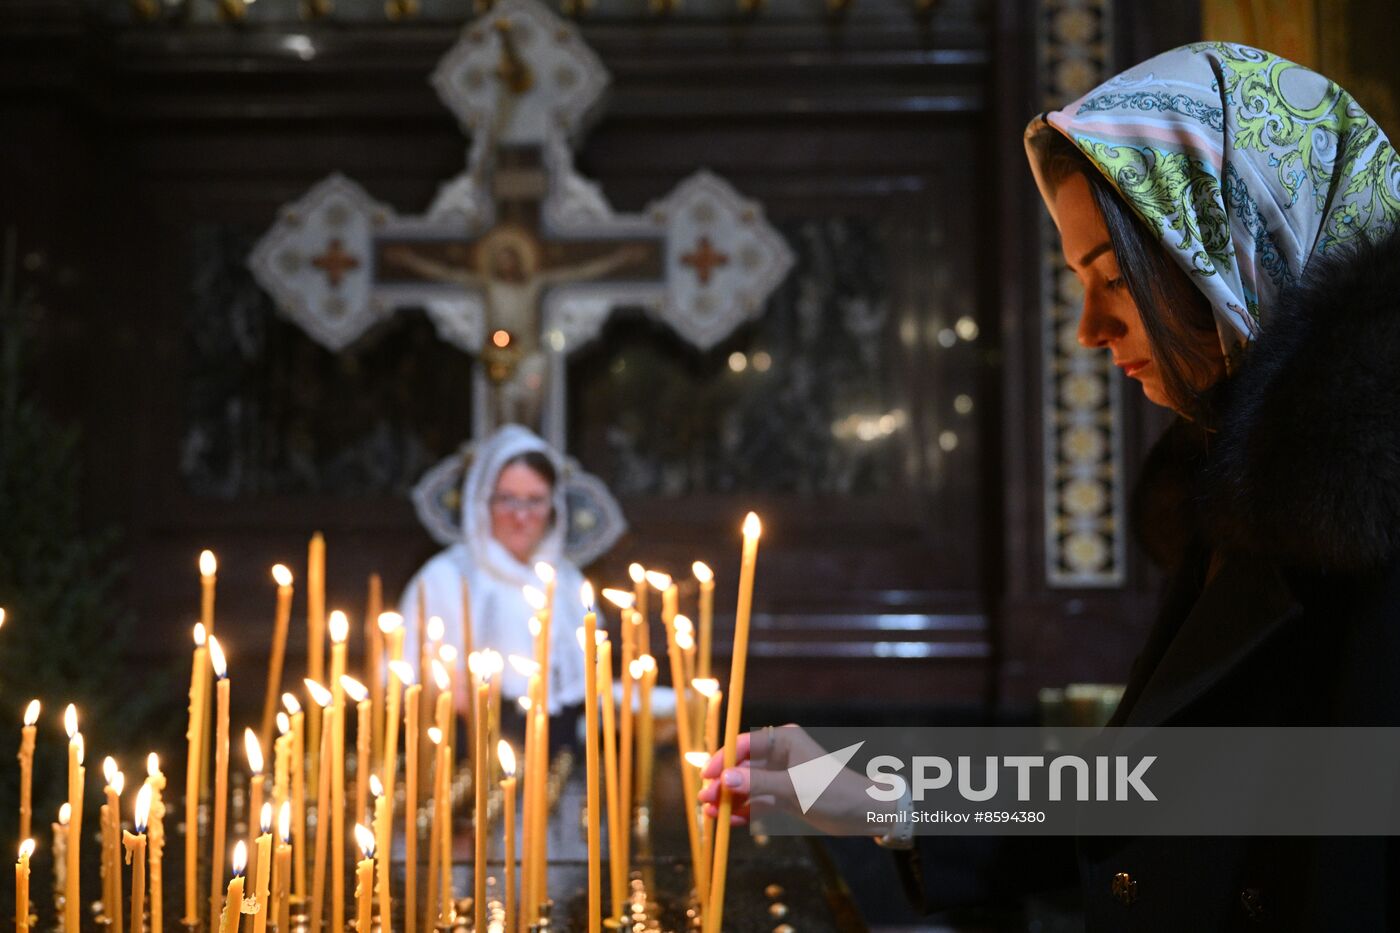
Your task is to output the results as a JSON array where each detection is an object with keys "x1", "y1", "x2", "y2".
[{"x1": 910, "y1": 226, "x2": 1400, "y2": 933}]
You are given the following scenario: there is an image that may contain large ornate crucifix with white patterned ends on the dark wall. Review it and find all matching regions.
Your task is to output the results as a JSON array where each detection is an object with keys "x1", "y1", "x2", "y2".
[{"x1": 249, "y1": 0, "x2": 792, "y2": 556}]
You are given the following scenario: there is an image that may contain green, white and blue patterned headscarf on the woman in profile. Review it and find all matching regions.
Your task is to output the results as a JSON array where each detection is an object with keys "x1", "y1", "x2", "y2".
[{"x1": 1026, "y1": 42, "x2": 1400, "y2": 360}]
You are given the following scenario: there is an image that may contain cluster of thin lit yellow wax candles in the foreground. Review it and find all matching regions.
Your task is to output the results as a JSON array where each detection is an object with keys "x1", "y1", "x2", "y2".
[{"x1": 10, "y1": 513, "x2": 760, "y2": 933}]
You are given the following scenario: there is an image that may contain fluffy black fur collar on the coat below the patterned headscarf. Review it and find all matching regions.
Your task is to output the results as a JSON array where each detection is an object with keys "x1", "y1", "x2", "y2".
[{"x1": 1138, "y1": 230, "x2": 1400, "y2": 572}]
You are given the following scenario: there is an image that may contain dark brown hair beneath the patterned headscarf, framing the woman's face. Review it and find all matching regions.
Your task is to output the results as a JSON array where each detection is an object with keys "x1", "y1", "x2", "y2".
[{"x1": 1030, "y1": 126, "x2": 1217, "y2": 417}]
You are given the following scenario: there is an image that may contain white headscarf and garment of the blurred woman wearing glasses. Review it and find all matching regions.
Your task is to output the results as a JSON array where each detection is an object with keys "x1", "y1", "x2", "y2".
[{"x1": 399, "y1": 424, "x2": 584, "y2": 713}]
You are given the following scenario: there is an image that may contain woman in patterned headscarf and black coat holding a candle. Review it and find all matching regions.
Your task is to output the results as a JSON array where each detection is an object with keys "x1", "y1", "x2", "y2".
[{"x1": 703, "y1": 43, "x2": 1400, "y2": 933}]
